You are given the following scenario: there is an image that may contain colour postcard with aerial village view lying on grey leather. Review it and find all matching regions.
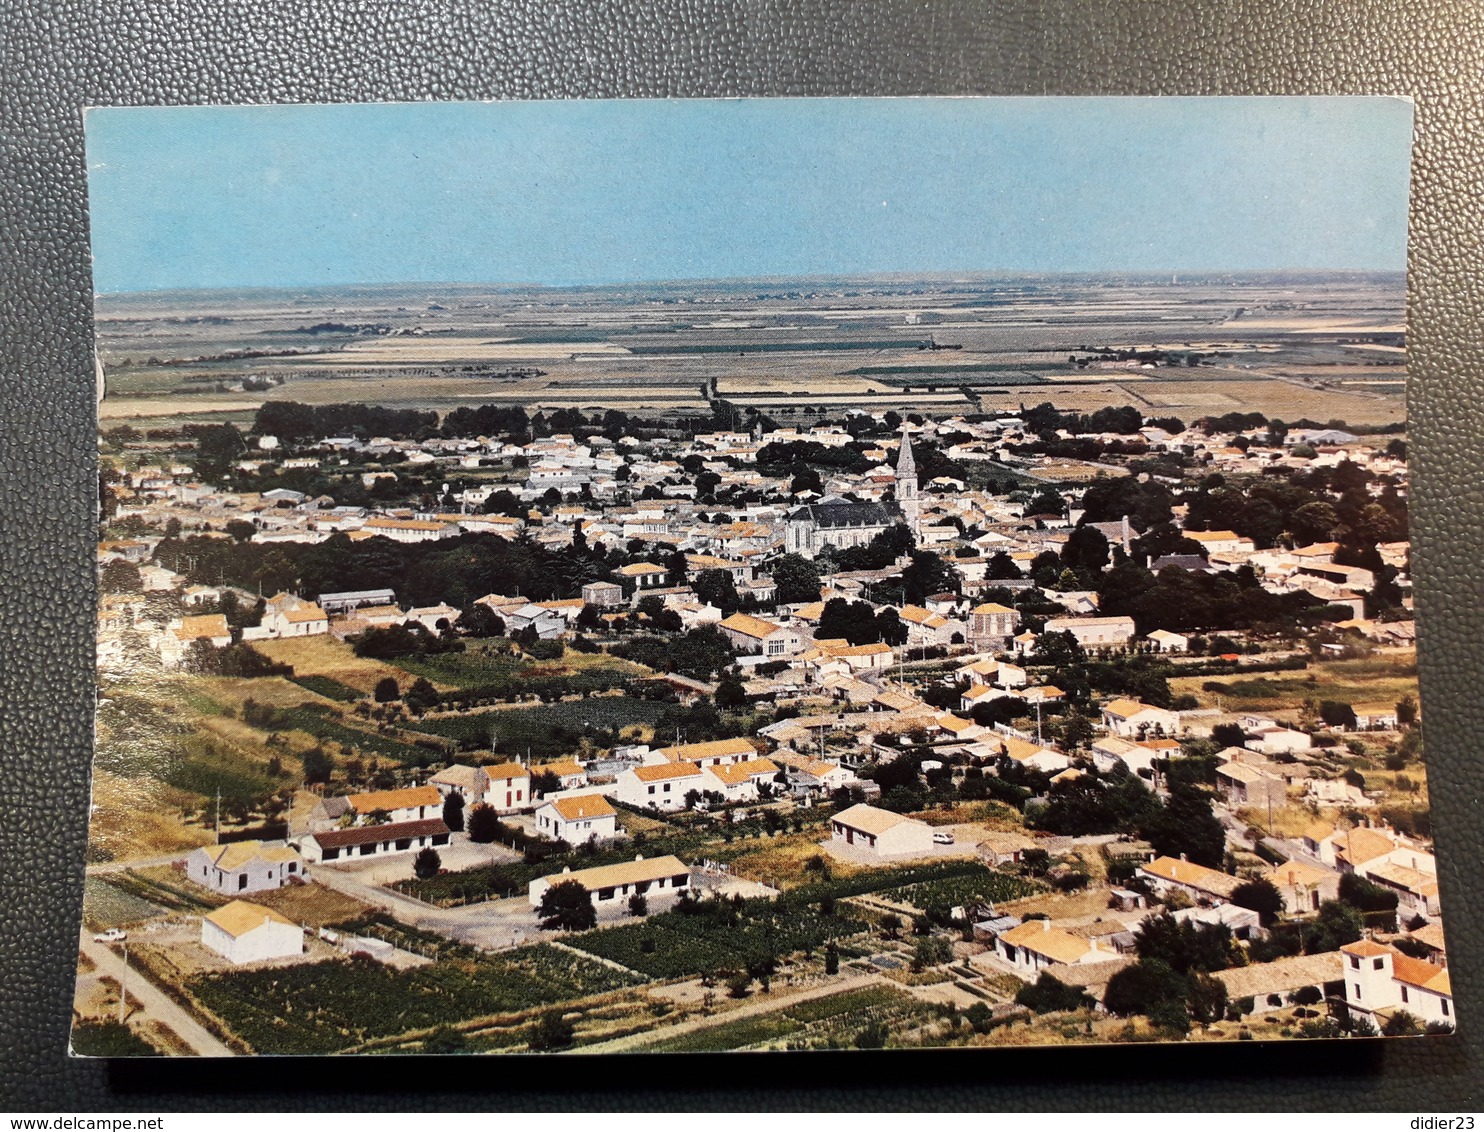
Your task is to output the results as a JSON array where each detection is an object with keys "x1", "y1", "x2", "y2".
[{"x1": 73, "y1": 98, "x2": 1454, "y2": 1056}]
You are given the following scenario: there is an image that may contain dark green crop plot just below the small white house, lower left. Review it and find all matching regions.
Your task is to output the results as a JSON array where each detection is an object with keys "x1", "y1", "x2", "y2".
[{"x1": 188, "y1": 944, "x2": 638, "y2": 1053}]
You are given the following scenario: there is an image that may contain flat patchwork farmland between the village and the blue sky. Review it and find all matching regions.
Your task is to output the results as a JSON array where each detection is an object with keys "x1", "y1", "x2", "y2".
[{"x1": 98, "y1": 273, "x2": 1405, "y2": 426}]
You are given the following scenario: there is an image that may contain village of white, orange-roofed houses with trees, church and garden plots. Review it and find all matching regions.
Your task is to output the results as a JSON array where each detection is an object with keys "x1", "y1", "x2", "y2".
[{"x1": 77, "y1": 401, "x2": 1453, "y2": 1053}]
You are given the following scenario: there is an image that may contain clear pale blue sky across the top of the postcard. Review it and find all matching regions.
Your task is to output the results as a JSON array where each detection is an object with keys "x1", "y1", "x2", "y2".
[{"x1": 86, "y1": 98, "x2": 1411, "y2": 292}]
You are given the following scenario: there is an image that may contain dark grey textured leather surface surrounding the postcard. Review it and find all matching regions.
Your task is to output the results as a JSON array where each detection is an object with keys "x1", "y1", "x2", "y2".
[{"x1": 0, "y1": 0, "x2": 1484, "y2": 1111}]
